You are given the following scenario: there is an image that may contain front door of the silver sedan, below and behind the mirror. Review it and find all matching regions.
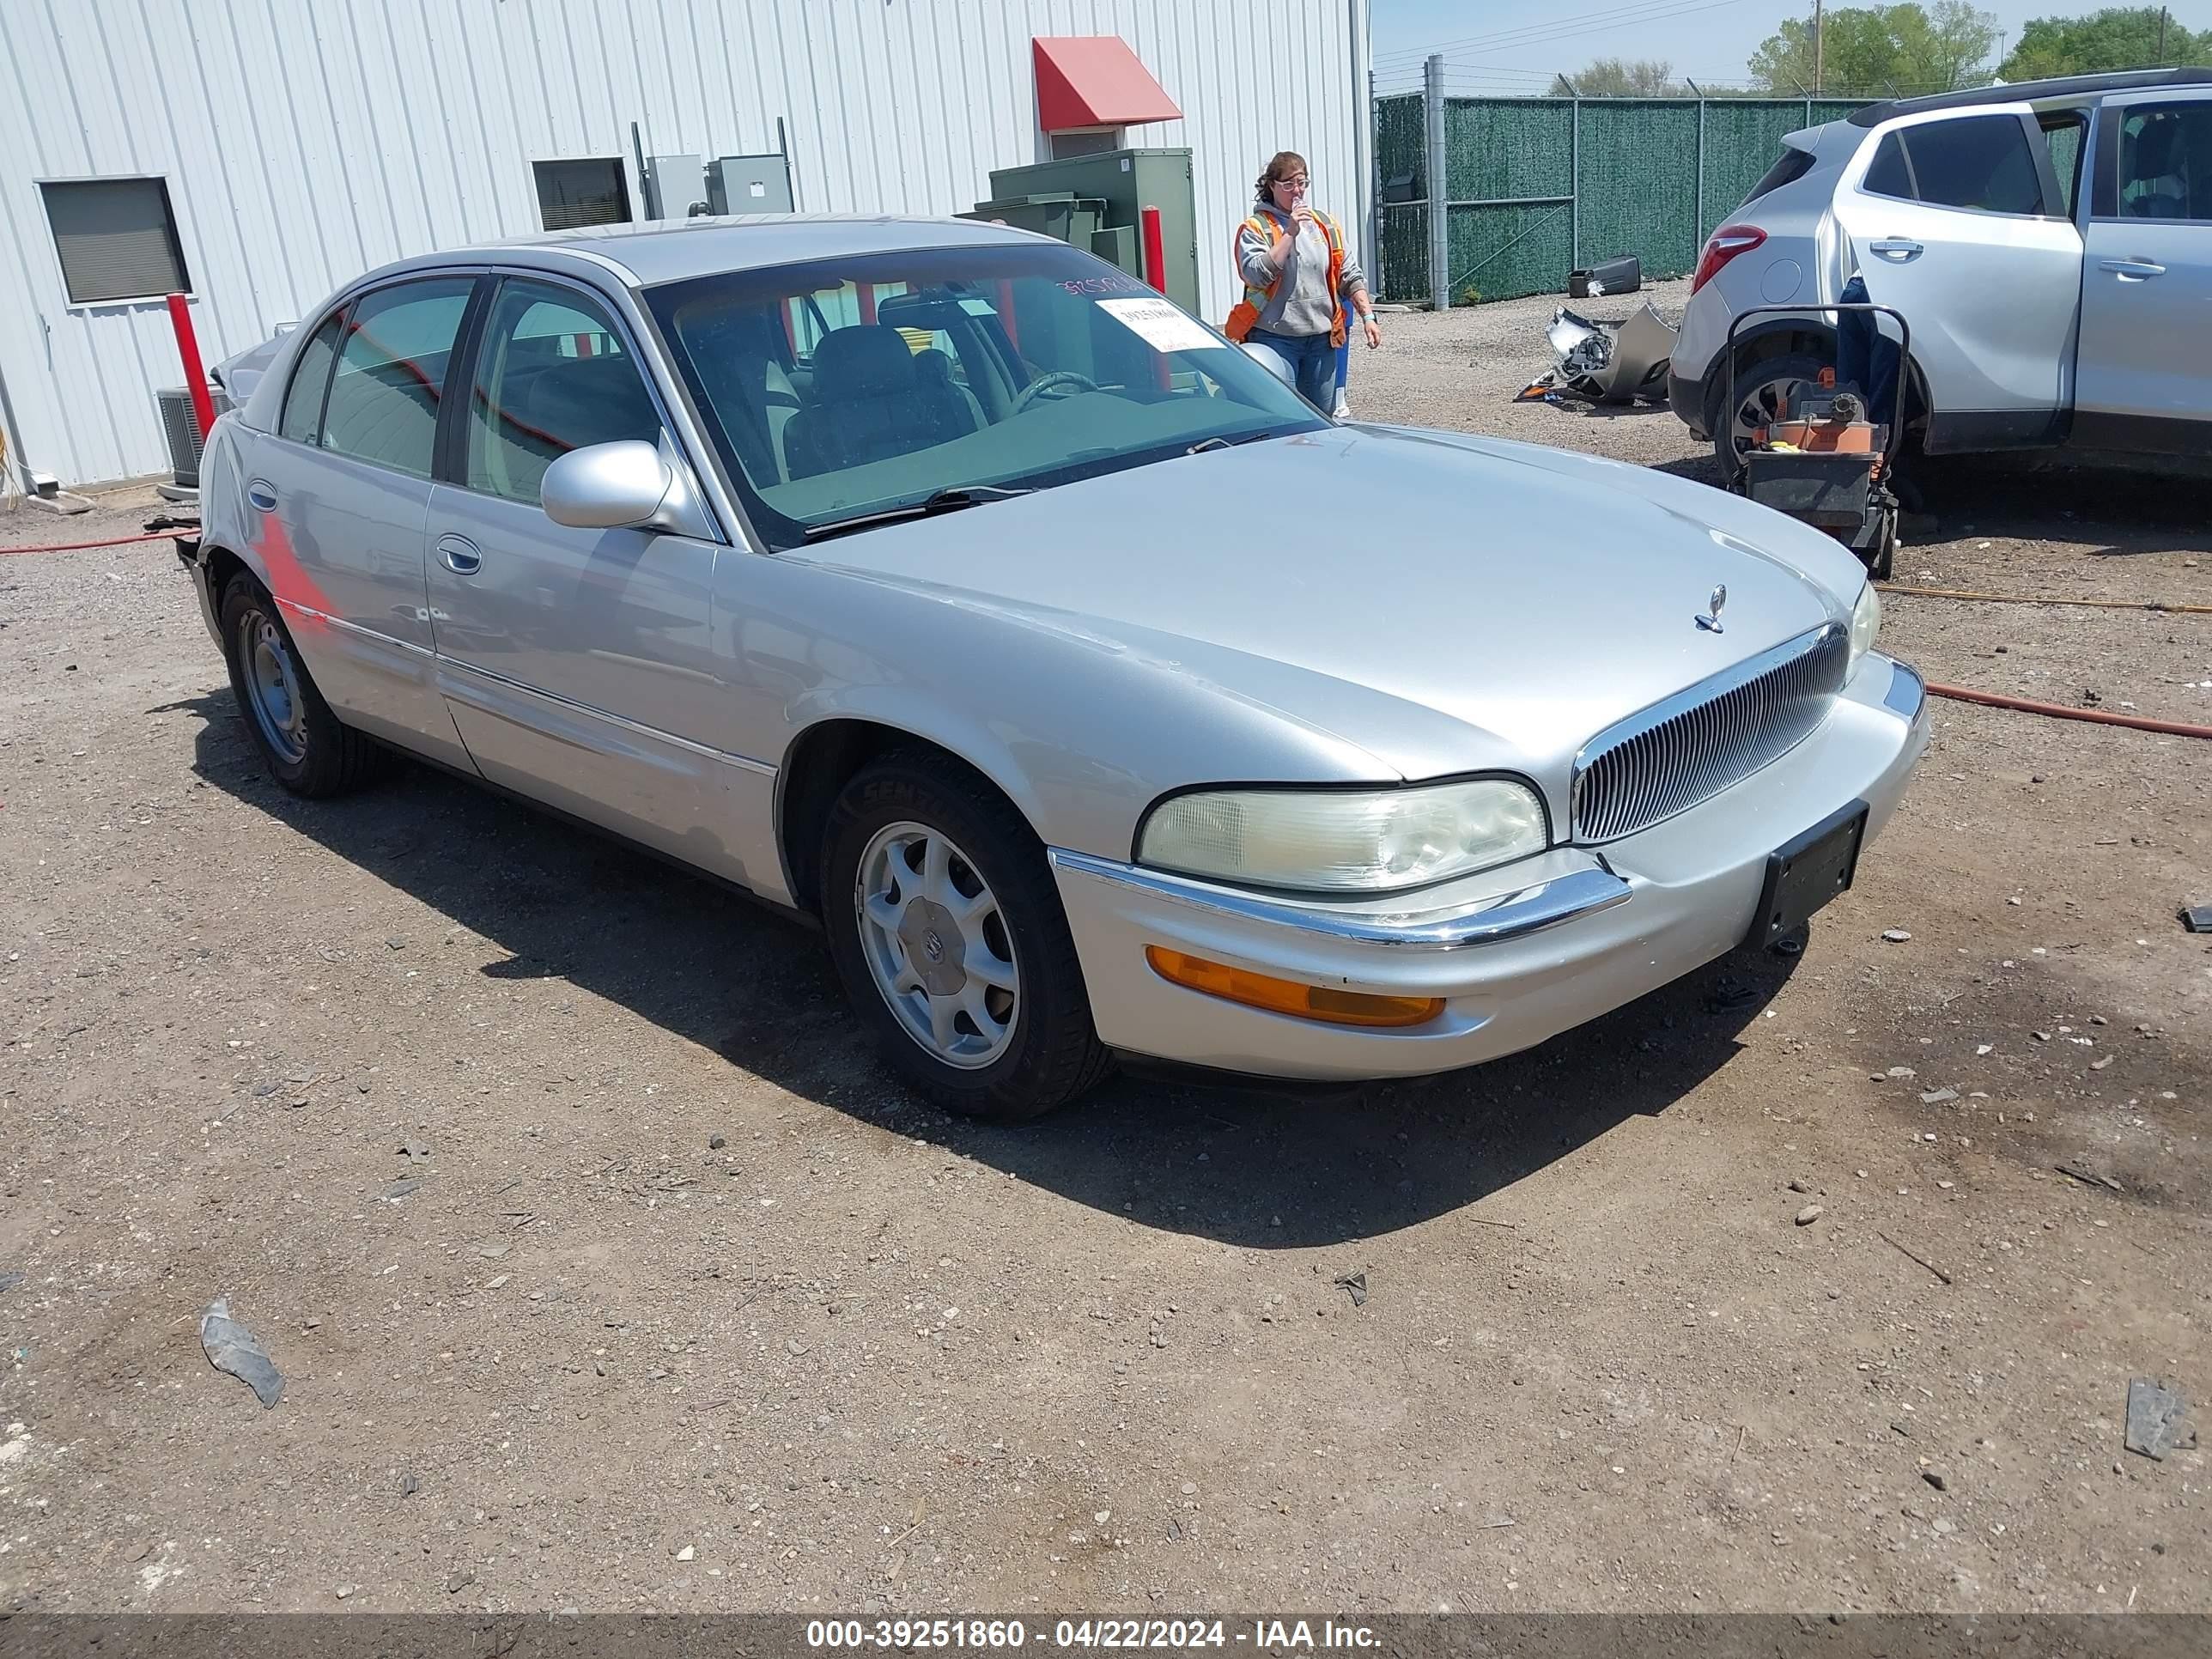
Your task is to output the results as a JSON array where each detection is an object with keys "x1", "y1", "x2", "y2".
[{"x1": 429, "y1": 276, "x2": 772, "y2": 883}]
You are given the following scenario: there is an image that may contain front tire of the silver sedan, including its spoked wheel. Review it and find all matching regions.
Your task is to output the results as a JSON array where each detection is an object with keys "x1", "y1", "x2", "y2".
[{"x1": 821, "y1": 752, "x2": 1113, "y2": 1124}]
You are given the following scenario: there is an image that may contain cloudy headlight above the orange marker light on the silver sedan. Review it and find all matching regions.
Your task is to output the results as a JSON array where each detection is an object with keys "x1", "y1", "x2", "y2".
[{"x1": 1137, "y1": 779, "x2": 1548, "y2": 894}]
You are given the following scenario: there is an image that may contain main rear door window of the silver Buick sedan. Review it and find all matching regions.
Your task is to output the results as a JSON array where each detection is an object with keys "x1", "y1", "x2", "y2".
[{"x1": 323, "y1": 276, "x2": 476, "y2": 477}]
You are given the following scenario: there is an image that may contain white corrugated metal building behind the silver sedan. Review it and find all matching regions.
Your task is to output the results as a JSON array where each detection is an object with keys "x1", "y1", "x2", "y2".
[{"x1": 0, "y1": 0, "x2": 1371, "y2": 484}]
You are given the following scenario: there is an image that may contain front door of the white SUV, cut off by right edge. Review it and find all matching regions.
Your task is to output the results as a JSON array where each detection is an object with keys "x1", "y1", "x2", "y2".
[{"x1": 2075, "y1": 91, "x2": 2212, "y2": 456}]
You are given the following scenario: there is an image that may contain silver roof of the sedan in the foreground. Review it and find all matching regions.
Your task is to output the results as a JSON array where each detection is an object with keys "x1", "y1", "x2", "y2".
[{"x1": 349, "y1": 212, "x2": 1051, "y2": 288}]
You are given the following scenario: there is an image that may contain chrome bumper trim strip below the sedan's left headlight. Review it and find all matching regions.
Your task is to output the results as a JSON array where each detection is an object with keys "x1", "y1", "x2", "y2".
[{"x1": 1051, "y1": 848, "x2": 1632, "y2": 951}]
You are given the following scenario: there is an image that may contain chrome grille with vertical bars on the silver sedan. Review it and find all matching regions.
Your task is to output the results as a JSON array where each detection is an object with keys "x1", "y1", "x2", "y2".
[{"x1": 1575, "y1": 623, "x2": 1851, "y2": 841}]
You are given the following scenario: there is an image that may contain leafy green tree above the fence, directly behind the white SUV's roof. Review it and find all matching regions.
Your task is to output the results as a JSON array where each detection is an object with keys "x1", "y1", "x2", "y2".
[{"x1": 1750, "y1": 0, "x2": 1997, "y2": 97}]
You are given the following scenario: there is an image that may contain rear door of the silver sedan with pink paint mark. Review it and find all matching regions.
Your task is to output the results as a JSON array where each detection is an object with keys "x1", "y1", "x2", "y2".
[{"x1": 246, "y1": 276, "x2": 476, "y2": 763}]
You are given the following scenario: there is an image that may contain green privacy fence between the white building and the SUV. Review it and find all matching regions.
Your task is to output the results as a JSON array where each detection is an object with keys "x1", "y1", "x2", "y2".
[{"x1": 1374, "y1": 93, "x2": 1858, "y2": 303}]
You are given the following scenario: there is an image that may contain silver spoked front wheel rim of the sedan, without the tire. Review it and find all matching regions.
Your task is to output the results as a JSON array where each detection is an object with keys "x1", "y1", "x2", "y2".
[{"x1": 852, "y1": 821, "x2": 1022, "y2": 1071}]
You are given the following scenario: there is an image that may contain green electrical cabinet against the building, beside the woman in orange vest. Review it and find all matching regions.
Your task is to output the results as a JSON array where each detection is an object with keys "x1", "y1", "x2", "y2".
[{"x1": 960, "y1": 150, "x2": 1228, "y2": 314}]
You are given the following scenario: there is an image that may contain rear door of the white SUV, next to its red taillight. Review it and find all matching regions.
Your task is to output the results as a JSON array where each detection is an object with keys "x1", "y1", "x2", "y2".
[{"x1": 1836, "y1": 104, "x2": 2081, "y2": 452}]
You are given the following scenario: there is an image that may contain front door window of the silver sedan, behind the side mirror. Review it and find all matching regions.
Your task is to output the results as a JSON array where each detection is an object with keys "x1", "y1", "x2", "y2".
[{"x1": 467, "y1": 281, "x2": 661, "y2": 504}]
